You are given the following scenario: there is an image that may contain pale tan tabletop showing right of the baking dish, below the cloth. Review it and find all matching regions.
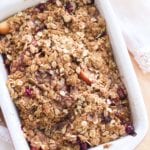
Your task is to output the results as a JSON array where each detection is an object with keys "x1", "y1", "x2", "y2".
[{"x1": 0, "y1": 56, "x2": 150, "y2": 150}]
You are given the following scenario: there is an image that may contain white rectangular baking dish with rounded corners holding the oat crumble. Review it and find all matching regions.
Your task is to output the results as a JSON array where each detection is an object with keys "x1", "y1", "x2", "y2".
[{"x1": 0, "y1": 0, "x2": 148, "y2": 150}]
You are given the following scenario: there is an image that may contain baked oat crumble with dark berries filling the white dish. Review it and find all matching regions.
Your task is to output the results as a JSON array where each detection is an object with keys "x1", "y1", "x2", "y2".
[{"x1": 0, "y1": 0, "x2": 135, "y2": 150}]
